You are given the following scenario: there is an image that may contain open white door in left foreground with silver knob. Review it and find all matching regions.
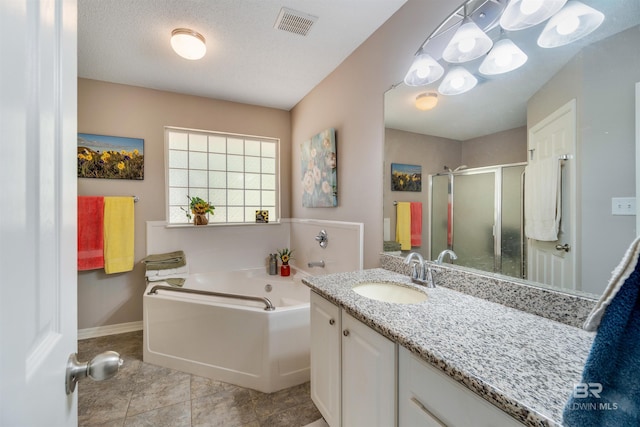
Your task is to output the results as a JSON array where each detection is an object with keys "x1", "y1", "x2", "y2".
[{"x1": 0, "y1": 0, "x2": 77, "y2": 427}]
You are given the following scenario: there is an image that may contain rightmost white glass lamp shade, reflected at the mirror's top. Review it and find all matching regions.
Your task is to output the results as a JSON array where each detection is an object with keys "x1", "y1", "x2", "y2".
[{"x1": 538, "y1": 0, "x2": 604, "y2": 48}]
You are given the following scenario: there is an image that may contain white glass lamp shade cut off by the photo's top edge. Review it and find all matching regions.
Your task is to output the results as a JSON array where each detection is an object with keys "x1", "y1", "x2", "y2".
[{"x1": 500, "y1": 0, "x2": 567, "y2": 31}]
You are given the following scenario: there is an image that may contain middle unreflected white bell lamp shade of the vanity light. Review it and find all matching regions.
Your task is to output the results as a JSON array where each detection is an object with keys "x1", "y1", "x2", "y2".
[{"x1": 442, "y1": 16, "x2": 493, "y2": 64}]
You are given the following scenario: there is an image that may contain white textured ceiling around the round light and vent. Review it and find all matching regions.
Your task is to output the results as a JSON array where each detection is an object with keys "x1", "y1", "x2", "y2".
[{"x1": 78, "y1": 0, "x2": 406, "y2": 110}]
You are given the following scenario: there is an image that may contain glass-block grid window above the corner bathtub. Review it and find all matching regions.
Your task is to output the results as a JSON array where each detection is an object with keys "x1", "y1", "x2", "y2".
[{"x1": 165, "y1": 127, "x2": 280, "y2": 224}]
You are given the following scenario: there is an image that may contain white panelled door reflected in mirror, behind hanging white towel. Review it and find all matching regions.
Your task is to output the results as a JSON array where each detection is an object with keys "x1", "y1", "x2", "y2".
[{"x1": 525, "y1": 100, "x2": 578, "y2": 289}]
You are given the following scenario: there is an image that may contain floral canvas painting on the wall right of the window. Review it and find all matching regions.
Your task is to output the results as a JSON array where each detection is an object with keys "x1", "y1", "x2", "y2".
[{"x1": 300, "y1": 128, "x2": 338, "y2": 208}]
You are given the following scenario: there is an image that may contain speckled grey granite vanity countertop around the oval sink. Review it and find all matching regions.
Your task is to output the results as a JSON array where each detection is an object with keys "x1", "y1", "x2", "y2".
[{"x1": 302, "y1": 269, "x2": 594, "y2": 426}]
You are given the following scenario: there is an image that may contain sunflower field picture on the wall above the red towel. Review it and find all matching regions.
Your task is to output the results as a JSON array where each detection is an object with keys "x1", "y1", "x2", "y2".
[{"x1": 77, "y1": 133, "x2": 144, "y2": 179}]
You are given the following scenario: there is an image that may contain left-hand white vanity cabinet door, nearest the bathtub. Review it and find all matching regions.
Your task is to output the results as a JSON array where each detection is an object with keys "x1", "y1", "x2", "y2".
[{"x1": 311, "y1": 292, "x2": 341, "y2": 427}]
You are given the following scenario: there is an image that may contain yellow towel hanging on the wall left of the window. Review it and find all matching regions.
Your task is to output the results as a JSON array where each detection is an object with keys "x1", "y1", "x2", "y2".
[{"x1": 104, "y1": 197, "x2": 134, "y2": 274}]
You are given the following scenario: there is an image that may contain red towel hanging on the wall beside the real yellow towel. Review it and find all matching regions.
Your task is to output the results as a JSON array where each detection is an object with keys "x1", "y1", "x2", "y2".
[{"x1": 78, "y1": 196, "x2": 104, "y2": 271}]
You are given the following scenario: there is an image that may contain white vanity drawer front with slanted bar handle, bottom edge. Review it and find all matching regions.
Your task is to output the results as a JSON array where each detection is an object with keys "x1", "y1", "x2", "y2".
[{"x1": 398, "y1": 347, "x2": 523, "y2": 427}]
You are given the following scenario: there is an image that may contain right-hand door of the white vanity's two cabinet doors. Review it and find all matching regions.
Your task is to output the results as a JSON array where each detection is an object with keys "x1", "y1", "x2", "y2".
[{"x1": 342, "y1": 312, "x2": 397, "y2": 427}]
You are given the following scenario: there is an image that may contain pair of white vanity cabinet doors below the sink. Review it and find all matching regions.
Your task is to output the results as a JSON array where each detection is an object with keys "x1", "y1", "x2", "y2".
[{"x1": 311, "y1": 292, "x2": 397, "y2": 427}]
